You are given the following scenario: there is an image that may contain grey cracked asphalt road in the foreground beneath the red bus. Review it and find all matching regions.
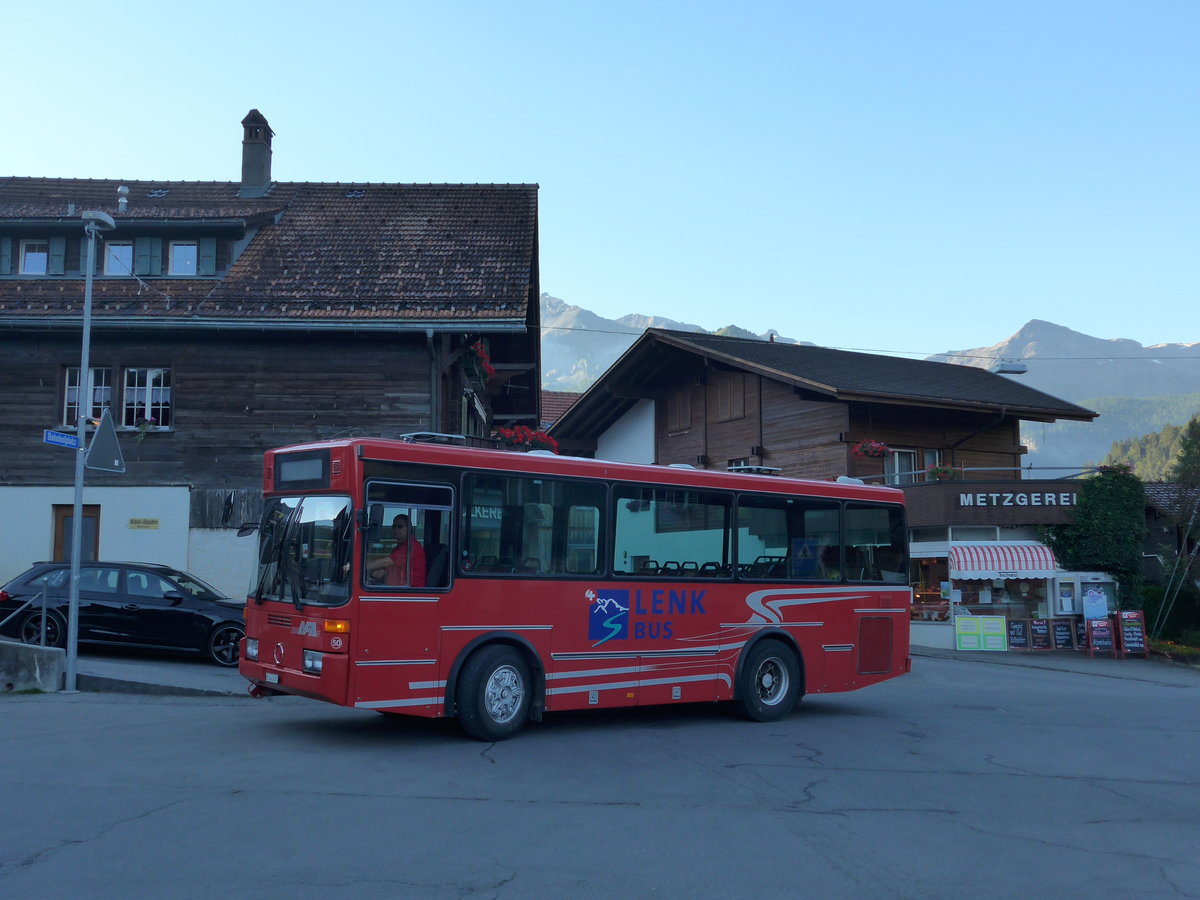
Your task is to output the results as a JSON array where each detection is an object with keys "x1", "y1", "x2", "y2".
[{"x1": 0, "y1": 656, "x2": 1200, "y2": 900}]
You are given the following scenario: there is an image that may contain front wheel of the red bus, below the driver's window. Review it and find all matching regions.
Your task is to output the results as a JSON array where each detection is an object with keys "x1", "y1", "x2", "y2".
[{"x1": 457, "y1": 644, "x2": 532, "y2": 740}]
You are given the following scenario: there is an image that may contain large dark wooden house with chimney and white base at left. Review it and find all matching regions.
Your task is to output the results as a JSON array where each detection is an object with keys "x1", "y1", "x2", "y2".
[{"x1": 0, "y1": 110, "x2": 540, "y2": 588}]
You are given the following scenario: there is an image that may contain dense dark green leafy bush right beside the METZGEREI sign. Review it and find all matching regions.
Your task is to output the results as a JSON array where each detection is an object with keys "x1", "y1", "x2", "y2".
[{"x1": 1042, "y1": 466, "x2": 1146, "y2": 608}]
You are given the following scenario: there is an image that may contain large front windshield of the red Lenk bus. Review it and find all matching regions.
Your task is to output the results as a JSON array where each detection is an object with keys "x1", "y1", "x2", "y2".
[{"x1": 254, "y1": 496, "x2": 353, "y2": 608}]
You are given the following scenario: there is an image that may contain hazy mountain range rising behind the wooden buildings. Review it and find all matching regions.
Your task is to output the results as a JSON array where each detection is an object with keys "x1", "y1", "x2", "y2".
[{"x1": 541, "y1": 294, "x2": 1200, "y2": 476}]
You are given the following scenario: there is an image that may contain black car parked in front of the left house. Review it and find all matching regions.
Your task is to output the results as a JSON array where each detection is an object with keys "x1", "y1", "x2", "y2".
[{"x1": 0, "y1": 562, "x2": 246, "y2": 666}]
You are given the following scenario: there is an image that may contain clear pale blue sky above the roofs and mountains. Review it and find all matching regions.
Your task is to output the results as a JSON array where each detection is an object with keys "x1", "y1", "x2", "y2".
[{"x1": 0, "y1": 0, "x2": 1200, "y2": 355}]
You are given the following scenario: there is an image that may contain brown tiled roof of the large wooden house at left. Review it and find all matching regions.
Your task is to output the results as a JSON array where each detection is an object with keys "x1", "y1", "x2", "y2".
[{"x1": 0, "y1": 178, "x2": 538, "y2": 323}]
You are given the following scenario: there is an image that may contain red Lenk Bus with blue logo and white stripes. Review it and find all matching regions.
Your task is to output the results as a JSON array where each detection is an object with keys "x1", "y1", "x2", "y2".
[{"x1": 239, "y1": 436, "x2": 911, "y2": 740}]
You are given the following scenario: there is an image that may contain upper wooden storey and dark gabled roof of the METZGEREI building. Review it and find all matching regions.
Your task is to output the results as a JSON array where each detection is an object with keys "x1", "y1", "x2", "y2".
[{"x1": 551, "y1": 329, "x2": 1094, "y2": 496}]
